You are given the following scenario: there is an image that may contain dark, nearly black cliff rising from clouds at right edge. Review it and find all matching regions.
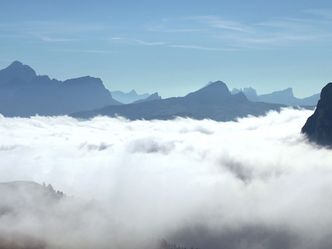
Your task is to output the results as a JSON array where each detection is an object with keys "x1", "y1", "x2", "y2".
[{"x1": 302, "y1": 83, "x2": 332, "y2": 147}]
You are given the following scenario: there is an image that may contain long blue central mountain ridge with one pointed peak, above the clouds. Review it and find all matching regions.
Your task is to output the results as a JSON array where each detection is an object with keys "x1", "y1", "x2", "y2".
[{"x1": 72, "y1": 81, "x2": 282, "y2": 121}]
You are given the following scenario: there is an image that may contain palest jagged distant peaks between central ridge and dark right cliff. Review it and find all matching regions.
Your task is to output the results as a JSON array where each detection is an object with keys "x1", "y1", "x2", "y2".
[{"x1": 232, "y1": 87, "x2": 319, "y2": 106}]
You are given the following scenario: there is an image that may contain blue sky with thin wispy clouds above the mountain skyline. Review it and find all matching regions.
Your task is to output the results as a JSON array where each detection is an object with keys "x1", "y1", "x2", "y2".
[{"x1": 0, "y1": 0, "x2": 332, "y2": 96}]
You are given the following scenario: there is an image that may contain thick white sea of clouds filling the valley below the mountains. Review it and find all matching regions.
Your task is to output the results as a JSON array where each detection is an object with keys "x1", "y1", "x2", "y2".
[{"x1": 0, "y1": 109, "x2": 332, "y2": 249}]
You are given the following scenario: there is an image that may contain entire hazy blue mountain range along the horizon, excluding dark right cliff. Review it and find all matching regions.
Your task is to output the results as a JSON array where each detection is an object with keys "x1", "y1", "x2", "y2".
[{"x1": 0, "y1": 61, "x2": 319, "y2": 118}]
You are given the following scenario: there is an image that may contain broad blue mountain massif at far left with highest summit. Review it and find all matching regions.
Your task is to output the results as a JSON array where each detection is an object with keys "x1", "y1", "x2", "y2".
[{"x1": 0, "y1": 61, "x2": 120, "y2": 116}]
